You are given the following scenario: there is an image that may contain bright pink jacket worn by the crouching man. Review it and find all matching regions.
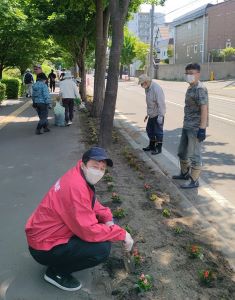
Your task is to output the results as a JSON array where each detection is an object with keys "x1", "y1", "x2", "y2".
[{"x1": 25, "y1": 161, "x2": 126, "y2": 250}]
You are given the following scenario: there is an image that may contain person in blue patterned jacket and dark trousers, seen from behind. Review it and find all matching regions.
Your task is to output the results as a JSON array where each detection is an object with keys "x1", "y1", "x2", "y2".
[{"x1": 32, "y1": 73, "x2": 51, "y2": 135}]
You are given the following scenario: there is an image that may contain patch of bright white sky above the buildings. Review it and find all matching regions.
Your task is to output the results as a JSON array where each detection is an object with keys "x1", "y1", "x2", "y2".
[{"x1": 140, "y1": 0, "x2": 223, "y2": 22}]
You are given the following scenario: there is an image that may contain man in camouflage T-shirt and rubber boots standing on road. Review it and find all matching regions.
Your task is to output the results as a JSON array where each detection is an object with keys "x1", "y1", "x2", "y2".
[{"x1": 172, "y1": 63, "x2": 208, "y2": 189}]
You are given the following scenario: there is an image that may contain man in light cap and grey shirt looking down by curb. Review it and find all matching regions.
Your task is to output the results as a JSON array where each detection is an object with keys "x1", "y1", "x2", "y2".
[{"x1": 139, "y1": 74, "x2": 166, "y2": 155}]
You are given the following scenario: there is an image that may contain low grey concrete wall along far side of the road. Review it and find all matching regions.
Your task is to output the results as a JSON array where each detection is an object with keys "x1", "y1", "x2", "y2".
[{"x1": 155, "y1": 62, "x2": 235, "y2": 80}]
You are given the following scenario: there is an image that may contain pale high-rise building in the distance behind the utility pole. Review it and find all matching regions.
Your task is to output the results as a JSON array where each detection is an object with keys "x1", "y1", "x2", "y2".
[{"x1": 127, "y1": 11, "x2": 165, "y2": 44}]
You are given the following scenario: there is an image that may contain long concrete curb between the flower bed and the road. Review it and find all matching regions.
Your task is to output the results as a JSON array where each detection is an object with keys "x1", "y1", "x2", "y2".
[{"x1": 114, "y1": 111, "x2": 235, "y2": 272}]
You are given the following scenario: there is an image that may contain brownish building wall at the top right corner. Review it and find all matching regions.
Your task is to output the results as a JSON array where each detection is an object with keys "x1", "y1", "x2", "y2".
[{"x1": 208, "y1": 0, "x2": 235, "y2": 51}]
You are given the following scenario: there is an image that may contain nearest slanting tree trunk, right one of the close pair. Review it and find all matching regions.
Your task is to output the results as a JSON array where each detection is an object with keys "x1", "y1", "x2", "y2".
[{"x1": 99, "y1": 0, "x2": 130, "y2": 148}]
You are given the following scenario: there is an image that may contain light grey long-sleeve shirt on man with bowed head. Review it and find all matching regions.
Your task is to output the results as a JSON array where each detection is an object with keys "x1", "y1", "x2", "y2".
[{"x1": 145, "y1": 81, "x2": 166, "y2": 118}]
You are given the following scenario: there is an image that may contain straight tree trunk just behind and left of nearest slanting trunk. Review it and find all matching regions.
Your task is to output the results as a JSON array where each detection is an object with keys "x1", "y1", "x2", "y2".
[{"x1": 91, "y1": 0, "x2": 110, "y2": 117}]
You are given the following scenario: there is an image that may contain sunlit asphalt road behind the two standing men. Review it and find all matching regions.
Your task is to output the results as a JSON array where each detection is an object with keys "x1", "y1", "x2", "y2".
[{"x1": 116, "y1": 81, "x2": 235, "y2": 267}]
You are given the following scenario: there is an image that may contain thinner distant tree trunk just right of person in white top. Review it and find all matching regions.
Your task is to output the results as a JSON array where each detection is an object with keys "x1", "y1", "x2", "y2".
[{"x1": 77, "y1": 38, "x2": 87, "y2": 101}]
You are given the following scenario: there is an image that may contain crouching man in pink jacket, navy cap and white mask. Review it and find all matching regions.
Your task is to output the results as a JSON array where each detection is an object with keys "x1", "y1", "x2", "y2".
[{"x1": 25, "y1": 147, "x2": 134, "y2": 291}]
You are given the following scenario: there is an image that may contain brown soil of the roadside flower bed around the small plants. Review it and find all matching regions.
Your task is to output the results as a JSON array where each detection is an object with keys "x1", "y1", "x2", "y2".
[{"x1": 79, "y1": 112, "x2": 235, "y2": 300}]
